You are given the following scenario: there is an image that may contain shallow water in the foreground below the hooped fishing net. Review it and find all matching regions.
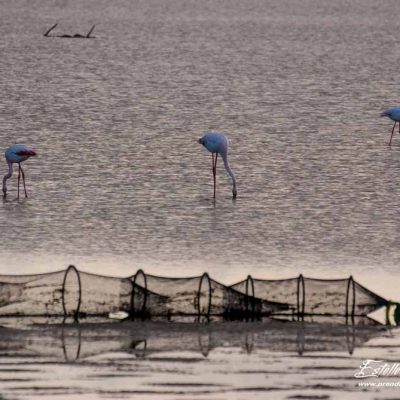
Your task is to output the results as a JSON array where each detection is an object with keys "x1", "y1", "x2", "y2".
[{"x1": 0, "y1": 320, "x2": 400, "y2": 399}]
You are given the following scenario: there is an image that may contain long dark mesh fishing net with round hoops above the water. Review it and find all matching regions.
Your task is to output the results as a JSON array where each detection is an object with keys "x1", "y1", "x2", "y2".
[{"x1": 0, "y1": 266, "x2": 389, "y2": 320}]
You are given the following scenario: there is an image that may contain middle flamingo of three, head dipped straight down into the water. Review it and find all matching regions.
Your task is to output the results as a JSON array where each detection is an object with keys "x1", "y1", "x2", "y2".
[{"x1": 198, "y1": 132, "x2": 237, "y2": 199}]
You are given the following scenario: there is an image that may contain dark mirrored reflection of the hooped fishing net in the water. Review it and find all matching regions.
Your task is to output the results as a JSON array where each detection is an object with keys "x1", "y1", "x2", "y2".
[{"x1": 0, "y1": 318, "x2": 388, "y2": 362}]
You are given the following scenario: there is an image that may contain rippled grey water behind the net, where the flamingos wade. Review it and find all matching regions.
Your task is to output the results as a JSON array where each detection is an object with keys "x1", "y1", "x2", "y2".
[{"x1": 0, "y1": 0, "x2": 400, "y2": 288}]
